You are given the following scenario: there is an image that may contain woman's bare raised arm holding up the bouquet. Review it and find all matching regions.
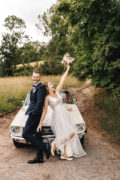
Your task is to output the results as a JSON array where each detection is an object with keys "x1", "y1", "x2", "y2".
[{"x1": 56, "y1": 64, "x2": 70, "y2": 93}]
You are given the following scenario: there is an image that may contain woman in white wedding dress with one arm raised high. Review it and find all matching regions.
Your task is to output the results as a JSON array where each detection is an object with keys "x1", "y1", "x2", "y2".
[{"x1": 37, "y1": 64, "x2": 86, "y2": 160}]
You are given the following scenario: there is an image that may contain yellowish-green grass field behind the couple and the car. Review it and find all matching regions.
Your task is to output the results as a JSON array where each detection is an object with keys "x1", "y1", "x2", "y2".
[{"x1": 0, "y1": 76, "x2": 80, "y2": 113}]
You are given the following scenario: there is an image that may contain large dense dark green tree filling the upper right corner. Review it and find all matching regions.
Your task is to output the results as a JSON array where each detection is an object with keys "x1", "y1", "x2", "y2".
[{"x1": 70, "y1": 0, "x2": 120, "y2": 92}]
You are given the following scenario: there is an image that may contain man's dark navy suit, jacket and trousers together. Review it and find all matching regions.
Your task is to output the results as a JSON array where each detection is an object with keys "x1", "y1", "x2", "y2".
[{"x1": 22, "y1": 83, "x2": 46, "y2": 158}]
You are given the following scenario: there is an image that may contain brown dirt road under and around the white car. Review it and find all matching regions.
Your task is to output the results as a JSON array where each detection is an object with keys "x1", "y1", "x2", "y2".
[{"x1": 0, "y1": 84, "x2": 120, "y2": 180}]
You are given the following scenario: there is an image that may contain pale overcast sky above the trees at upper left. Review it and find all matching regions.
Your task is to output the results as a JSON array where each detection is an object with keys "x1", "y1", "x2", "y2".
[{"x1": 0, "y1": 0, "x2": 57, "y2": 42}]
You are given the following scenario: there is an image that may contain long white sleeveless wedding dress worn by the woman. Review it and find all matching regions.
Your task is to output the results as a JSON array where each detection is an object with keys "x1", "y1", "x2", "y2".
[{"x1": 48, "y1": 92, "x2": 86, "y2": 157}]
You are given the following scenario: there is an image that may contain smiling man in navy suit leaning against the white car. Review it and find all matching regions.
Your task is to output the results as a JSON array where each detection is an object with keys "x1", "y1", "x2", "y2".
[{"x1": 22, "y1": 70, "x2": 50, "y2": 164}]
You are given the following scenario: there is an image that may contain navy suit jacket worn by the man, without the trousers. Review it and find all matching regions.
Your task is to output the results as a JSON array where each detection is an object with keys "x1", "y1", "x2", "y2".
[{"x1": 26, "y1": 83, "x2": 47, "y2": 117}]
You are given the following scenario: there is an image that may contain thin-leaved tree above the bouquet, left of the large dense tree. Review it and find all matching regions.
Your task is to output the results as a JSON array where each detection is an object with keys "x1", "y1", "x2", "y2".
[{"x1": 36, "y1": 4, "x2": 72, "y2": 60}]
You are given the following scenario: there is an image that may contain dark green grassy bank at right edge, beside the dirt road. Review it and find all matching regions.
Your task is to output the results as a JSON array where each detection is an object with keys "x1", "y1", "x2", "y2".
[{"x1": 95, "y1": 92, "x2": 120, "y2": 141}]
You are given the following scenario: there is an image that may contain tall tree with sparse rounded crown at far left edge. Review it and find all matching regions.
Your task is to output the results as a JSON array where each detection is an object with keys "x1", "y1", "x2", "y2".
[{"x1": 0, "y1": 16, "x2": 28, "y2": 76}]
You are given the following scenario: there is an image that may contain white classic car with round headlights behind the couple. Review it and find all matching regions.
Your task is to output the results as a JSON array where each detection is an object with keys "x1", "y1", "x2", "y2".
[{"x1": 10, "y1": 90, "x2": 87, "y2": 147}]
